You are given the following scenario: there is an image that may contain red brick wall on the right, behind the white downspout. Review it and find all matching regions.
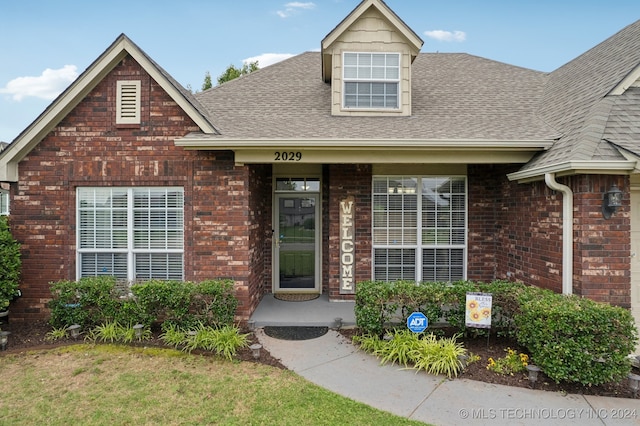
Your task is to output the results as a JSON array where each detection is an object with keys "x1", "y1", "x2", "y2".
[{"x1": 468, "y1": 165, "x2": 631, "y2": 307}]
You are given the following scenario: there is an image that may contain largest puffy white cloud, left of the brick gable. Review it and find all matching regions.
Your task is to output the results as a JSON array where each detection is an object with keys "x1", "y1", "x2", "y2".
[{"x1": 0, "y1": 65, "x2": 78, "y2": 101}]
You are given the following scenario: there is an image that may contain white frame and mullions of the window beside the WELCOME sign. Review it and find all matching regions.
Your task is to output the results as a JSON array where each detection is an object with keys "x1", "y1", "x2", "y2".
[{"x1": 371, "y1": 175, "x2": 469, "y2": 282}]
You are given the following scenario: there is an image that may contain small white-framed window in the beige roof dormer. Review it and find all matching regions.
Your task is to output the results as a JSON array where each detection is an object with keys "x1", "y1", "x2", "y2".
[{"x1": 343, "y1": 53, "x2": 400, "y2": 109}]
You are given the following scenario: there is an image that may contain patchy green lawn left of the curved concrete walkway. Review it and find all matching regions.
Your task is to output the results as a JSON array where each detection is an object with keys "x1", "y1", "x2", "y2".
[{"x1": 0, "y1": 344, "x2": 430, "y2": 426}]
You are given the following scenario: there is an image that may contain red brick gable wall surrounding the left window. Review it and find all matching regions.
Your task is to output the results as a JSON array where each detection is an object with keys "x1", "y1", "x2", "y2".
[{"x1": 11, "y1": 58, "x2": 265, "y2": 321}]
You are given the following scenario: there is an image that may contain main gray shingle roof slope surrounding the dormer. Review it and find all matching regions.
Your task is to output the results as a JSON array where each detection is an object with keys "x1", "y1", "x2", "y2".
[{"x1": 196, "y1": 52, "x2": 559, "y2": 143}]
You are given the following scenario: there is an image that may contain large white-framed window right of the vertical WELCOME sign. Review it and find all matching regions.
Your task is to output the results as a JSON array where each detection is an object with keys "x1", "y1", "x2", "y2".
[{"x1": 373, "y1": 176, "x2": 467, "y2": 282}]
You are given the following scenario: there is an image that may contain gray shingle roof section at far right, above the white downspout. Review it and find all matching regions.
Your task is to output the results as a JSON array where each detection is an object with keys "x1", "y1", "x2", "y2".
[{"x1": 509, "y1": 20, "x2": 640, "y2": 179}]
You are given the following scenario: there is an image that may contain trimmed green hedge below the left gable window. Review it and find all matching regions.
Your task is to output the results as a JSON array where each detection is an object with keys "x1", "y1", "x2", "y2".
[{"x1": 49, "y1": 276, "x2": 238, "y2": 328}]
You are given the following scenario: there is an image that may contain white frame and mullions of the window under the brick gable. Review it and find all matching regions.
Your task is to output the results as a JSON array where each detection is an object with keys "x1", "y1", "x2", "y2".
[{"x1": 76, "y1": 186, "x2": 184, "y2": 282}]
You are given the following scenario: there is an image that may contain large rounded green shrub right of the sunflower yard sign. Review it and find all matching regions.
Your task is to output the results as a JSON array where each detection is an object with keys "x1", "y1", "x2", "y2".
[{"x1": 515, "y1": 293, "x2": 637, "y2": 385}]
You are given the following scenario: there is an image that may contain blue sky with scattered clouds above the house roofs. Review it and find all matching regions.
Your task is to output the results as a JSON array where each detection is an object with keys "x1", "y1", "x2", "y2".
[{"x1": 0, "y1": 0, "x2": 640, "y2": 142}]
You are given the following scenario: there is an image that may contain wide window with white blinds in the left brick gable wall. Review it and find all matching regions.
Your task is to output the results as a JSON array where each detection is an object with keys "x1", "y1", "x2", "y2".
[{"x1": 77, "y1": 187, "x2": 184, "y2": 281}]
